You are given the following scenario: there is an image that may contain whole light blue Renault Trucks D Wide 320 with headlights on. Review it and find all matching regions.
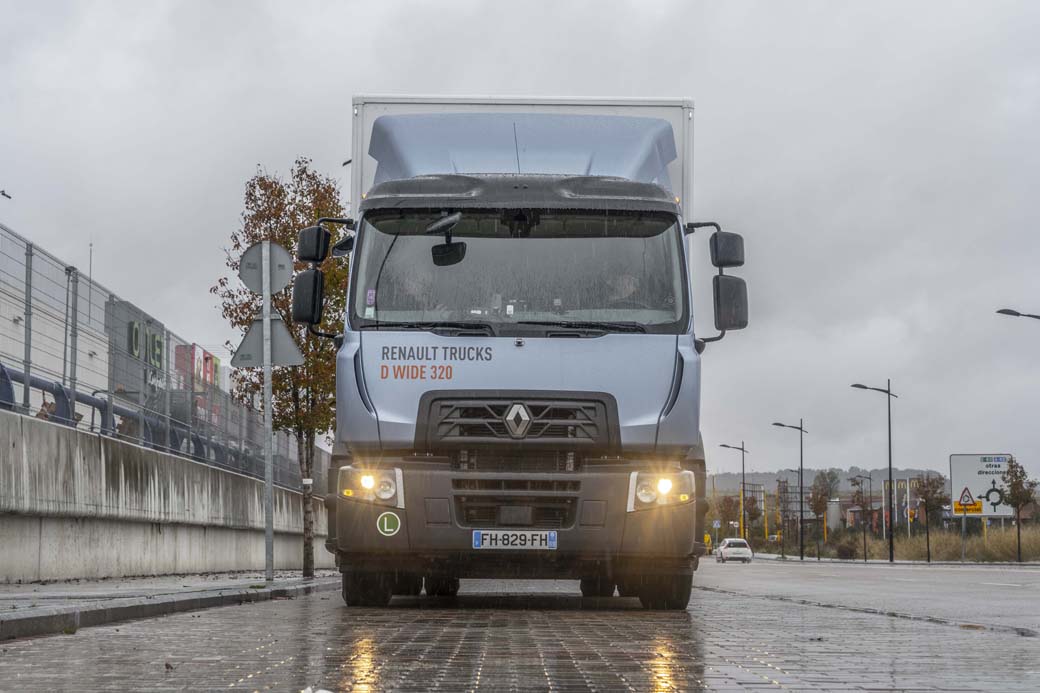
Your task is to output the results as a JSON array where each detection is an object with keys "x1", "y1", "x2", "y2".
[{"x1": 293, "y1": 98, "x2": 747, "y2": 609}]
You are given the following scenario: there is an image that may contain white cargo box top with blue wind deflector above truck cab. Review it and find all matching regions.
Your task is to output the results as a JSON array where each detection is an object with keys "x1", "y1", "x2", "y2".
[{"x1": 350, "y1": 96, "x2": 694, "y2": 210}]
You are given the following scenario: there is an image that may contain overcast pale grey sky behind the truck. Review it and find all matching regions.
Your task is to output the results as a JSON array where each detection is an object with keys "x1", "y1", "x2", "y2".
[{"x1": 0, "y1": 0, "x2": 1040, "y2": 476}]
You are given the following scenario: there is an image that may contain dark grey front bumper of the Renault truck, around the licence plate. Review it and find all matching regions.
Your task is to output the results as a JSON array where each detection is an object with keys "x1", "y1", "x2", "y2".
[{"x1": 330, "y1": 468, "x2": 703, "y2": 578}]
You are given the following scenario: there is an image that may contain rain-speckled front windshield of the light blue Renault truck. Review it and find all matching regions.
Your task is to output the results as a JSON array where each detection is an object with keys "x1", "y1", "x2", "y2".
[{"x1": 352, "y1": 209, "x2": 687, "y2": 334}]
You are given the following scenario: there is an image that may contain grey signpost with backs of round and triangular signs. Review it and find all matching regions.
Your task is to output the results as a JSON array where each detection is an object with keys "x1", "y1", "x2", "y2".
[{"x1": 231, "y1": 240, "x2": 304, "y2": 583}]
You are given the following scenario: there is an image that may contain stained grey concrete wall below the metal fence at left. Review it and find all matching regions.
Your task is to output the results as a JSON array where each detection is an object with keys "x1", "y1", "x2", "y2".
[{"x1": 0, "y1": 412, "x2": 334, "y2": 582}]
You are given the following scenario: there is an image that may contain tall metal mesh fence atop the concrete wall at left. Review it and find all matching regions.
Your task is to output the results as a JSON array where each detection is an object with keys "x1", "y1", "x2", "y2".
[{"x1": 0, "y1": 219, "x2": 312, "y2": 484}]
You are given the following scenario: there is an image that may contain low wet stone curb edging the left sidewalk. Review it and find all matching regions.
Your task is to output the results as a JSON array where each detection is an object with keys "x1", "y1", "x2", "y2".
[{"x1": 0, "y1": 578, "x2": 340, "y2": 641}]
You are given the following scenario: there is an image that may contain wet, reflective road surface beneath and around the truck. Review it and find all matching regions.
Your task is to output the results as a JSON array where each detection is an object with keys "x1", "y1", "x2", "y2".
[{"x1": 0, "y1": 561, "x2": 1040, "y2": 691}]
